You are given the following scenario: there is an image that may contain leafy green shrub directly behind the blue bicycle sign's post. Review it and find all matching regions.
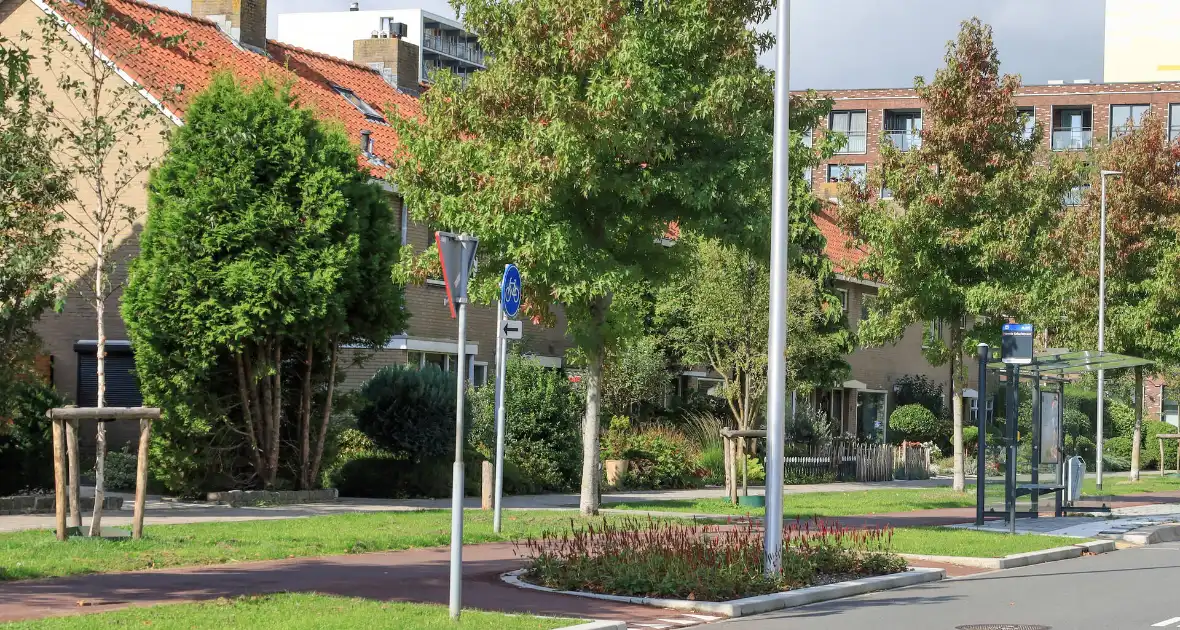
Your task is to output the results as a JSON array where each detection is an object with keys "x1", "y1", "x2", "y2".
[{"x1": 468, "y1": 355, "x2": 585, "y2": 492}]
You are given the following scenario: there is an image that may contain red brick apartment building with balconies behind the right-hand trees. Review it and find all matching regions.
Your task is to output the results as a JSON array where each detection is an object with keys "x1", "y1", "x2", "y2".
[{"x1": 811, "y1": 81, "x2": 1180, "y2": 426}]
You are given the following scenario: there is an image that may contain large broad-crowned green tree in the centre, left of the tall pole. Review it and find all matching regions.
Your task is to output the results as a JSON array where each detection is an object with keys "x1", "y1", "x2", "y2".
[{"x1": 392, "y1": 0, "x2": 772, "y2": 513}]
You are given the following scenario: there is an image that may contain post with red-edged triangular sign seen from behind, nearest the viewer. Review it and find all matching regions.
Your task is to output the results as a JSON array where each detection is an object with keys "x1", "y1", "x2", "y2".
[{"x1": 434, "y1": 232, "x2": 479, "y2": 619}]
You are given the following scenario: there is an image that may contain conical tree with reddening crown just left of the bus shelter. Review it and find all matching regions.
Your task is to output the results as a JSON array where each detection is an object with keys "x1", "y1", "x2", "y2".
[{"x1": 841, "y1": 19, "x2": 1073, "y2": 491}]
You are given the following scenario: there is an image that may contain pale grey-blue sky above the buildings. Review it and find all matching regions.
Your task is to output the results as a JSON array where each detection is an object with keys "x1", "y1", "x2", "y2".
[{"x1": 155, "y1": 0, "x2": 1104, "y2": 90}]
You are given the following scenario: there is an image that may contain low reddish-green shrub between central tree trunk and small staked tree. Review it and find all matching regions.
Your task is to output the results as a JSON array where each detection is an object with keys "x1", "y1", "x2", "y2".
[{"x1": 623, "y1": 427, "x2": 701, "y2": 490}]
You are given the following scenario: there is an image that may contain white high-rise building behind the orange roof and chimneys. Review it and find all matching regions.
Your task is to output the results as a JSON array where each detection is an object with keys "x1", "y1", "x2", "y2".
[{"x1": 275, "y1": 8, "x2": 485, "y2": 81}]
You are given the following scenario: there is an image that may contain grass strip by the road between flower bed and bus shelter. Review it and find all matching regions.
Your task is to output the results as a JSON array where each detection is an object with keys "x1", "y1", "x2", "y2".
[{"x1": 892, "y1": 527, "x2": 1086, "y2": 558}]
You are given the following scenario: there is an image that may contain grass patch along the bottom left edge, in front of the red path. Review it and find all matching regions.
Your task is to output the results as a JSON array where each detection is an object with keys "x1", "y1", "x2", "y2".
[{"x1": 0, "y1": 593, "x2": 581, "y2": 630}]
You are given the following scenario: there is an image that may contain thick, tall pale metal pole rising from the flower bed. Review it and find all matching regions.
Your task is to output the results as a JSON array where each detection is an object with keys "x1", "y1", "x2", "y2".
[{"x1": 762, "y1": 0, "x2": 791, "y2": 575}]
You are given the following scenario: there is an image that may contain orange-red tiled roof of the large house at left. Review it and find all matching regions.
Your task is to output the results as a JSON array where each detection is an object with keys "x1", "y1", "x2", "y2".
[{"x1": 51, "y1": 0, "x2": 419, "y2": 177}]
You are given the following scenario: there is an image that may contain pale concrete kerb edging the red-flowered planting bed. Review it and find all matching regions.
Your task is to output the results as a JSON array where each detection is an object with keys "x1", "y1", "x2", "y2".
[{"x1": 500, "y1": 567, "x2": 946, "y2": 617}]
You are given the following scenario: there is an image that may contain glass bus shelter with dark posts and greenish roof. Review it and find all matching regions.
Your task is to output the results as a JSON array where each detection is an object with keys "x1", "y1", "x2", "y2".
[{"x1": 976, "y1": 343, "x2": 1152, "y2": 532}]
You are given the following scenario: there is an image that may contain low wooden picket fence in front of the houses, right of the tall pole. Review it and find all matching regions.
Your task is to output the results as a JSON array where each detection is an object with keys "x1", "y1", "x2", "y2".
[{"x1": 784, "y1": 440, "x2": 930, "y2": 484}]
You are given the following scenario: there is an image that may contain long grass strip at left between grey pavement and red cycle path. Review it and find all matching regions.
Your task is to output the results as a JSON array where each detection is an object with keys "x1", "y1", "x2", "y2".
[{"x1": 0, "y1": 510, "x2": 617, "y2": 580}]
